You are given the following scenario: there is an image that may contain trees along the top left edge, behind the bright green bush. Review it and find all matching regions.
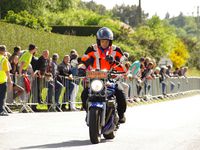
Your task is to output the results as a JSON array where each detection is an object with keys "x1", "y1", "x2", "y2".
[{"x1": 0, "y1": 0, "x2": 80, "y2": 18}]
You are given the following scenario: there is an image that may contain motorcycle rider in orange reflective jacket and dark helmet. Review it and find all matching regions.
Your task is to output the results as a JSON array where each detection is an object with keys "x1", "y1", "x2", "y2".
[{"x1": 79, "y1": 27, "x2": 126, "y2": 123}]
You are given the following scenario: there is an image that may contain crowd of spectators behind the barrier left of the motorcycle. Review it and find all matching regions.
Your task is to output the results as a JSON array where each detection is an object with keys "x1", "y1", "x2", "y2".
[{"x1": 1, "y1": 44, "x2": 80, "y2": 114}]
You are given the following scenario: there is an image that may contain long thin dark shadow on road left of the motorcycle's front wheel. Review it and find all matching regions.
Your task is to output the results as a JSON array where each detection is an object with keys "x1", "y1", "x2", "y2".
[{"x1": 19, "y1": 139, "x2": 105, "y2": 149}]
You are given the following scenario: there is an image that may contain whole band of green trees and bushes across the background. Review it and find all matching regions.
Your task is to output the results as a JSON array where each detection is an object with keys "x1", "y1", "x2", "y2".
[{"x1": 0, "y1": 0, "x2": 200, "y2": 68}]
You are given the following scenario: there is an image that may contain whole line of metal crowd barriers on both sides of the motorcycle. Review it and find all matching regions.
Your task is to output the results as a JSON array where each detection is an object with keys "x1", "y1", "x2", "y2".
[{"x1": 5, "y1": 76, "x2": 200, "y2": 112}]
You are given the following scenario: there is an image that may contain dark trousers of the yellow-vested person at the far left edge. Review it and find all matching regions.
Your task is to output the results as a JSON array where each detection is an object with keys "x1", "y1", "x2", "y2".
[{"x1": 0, "y1": 82, "x2": 7, "y2": 112}]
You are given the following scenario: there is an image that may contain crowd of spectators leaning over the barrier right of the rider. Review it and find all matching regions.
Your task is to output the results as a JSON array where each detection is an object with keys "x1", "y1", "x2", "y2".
[{"x1": 129, "y1": 57, "x2": 188, "y2": 101}]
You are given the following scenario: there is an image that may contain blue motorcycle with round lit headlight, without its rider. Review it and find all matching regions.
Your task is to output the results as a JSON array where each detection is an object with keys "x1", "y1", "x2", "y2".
[{"x1": 83, "y1": 68, "x2": 123, "y2": 144}]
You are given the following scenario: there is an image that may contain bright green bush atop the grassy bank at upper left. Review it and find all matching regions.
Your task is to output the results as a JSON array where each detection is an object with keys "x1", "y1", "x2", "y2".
[{"x1": 4, "y1": 10, "x2": 51, "y2": 31}]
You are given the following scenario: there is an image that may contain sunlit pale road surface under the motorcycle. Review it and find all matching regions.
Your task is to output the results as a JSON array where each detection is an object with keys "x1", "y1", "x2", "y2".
[{"x1": 0, "y1": 95, "x2": 200, "y2": 150}]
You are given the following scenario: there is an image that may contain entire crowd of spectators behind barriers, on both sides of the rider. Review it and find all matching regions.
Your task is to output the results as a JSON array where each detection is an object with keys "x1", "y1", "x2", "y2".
[{"x1": 0, "y1": 44, "x2": 187, "y2": 115}]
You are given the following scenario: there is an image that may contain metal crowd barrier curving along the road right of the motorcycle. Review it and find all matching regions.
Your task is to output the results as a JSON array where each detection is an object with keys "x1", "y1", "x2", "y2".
[{"x1": 126, "y1": 77, "x2": 200, "y2": 98}]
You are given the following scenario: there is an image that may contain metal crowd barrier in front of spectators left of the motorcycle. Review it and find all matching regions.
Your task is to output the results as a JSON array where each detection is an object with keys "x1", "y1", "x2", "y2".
[{"x1": 5, "y1": 76, "x2": 81, "y2": 112}]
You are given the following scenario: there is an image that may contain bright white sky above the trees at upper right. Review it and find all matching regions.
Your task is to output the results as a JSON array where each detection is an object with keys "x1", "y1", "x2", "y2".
[{"x1": 83, "y1": 0, "x2": 200, "y2": 19}]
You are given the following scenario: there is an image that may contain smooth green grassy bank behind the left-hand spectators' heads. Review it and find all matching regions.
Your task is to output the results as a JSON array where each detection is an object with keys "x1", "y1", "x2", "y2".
[{"x1": 0, "y1": 22, "x2": 95, "y2": 58}]
